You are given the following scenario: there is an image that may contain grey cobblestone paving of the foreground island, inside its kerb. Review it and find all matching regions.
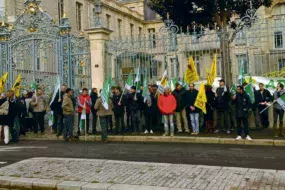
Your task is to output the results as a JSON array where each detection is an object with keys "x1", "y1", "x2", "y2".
[{"x1": 0, "y1": 158, "x2": 285, "y2": 190}]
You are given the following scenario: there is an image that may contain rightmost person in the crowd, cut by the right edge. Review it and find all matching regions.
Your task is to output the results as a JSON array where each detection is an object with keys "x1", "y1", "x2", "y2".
[{"x1": 273, "y1": 83, "x2": 285, "y2": 138}]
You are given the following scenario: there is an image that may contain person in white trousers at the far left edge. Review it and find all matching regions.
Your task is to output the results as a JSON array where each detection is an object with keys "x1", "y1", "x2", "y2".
[{"x1": 0, "y1": 93, "x2": 10, "y2": 144}]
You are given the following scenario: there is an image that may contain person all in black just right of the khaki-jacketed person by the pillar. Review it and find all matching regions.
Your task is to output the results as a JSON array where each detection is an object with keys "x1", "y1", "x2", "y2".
[{"x1": 112, "y1": 86, "x2": 125, "y2": 135}]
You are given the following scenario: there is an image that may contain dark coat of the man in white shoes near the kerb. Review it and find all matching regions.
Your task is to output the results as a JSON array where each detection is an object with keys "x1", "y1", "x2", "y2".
[{"x1": 234, "y1": 92, "x2": 251, "y2": 118}]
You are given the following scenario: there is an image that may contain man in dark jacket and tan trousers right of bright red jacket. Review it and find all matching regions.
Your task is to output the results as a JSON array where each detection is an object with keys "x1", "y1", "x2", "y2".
[{"x1": 172, "y1": 83, "x2": 190, "y2": 133}]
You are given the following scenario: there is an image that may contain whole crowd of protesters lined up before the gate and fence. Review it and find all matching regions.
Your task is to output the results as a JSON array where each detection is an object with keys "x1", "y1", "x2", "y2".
[{"x1": 0, "y1": 79, "x2": 285, "y2": 144}]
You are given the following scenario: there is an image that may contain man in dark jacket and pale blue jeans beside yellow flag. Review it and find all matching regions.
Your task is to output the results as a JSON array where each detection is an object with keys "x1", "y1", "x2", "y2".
[{"x1": 186, "y1": 83, "x2": 201, "y2": 135}]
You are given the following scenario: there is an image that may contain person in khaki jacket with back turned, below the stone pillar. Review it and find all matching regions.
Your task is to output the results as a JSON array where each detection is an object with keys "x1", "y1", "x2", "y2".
[{"x1": 94, "y1": 90, "x2": 113, "y2": 142}]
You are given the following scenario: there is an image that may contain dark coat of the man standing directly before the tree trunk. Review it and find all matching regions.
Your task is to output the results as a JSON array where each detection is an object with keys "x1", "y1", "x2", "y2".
[{"x1": 216, "y1": 87, "x2": 231, "y2": 111}]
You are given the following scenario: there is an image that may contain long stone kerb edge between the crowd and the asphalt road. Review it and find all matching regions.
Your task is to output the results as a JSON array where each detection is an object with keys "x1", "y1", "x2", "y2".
[{"x1": 21, "y1": 136, "x2": 285, "y2": 146}]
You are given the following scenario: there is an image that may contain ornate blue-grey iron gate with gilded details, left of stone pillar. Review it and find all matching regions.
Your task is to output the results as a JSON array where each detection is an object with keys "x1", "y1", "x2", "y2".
[{"x1": 0, "y1": 0, "x2": 91, "y2": 92}]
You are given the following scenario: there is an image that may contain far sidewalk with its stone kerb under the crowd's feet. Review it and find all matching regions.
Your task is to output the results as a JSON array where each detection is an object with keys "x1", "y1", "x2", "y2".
[{"x1": 21, "y1": 129, "x2": 285, "y2": 146}]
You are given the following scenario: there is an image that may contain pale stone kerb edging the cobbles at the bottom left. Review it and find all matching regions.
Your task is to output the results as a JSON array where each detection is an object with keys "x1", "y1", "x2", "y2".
[{"x1": 0, "y1": 176, "x2": 189, "y2": 190}]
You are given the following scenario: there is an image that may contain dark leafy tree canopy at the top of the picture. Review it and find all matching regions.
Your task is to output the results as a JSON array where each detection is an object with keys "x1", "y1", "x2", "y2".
[{"x1": 149, "y1": 0, "x2": 272, "y2": 31}]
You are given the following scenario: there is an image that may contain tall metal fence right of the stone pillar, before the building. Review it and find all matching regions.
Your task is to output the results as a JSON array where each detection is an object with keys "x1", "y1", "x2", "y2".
[{"x1": 106, "y1": 6, "x2": 285, "y2": 85}]
